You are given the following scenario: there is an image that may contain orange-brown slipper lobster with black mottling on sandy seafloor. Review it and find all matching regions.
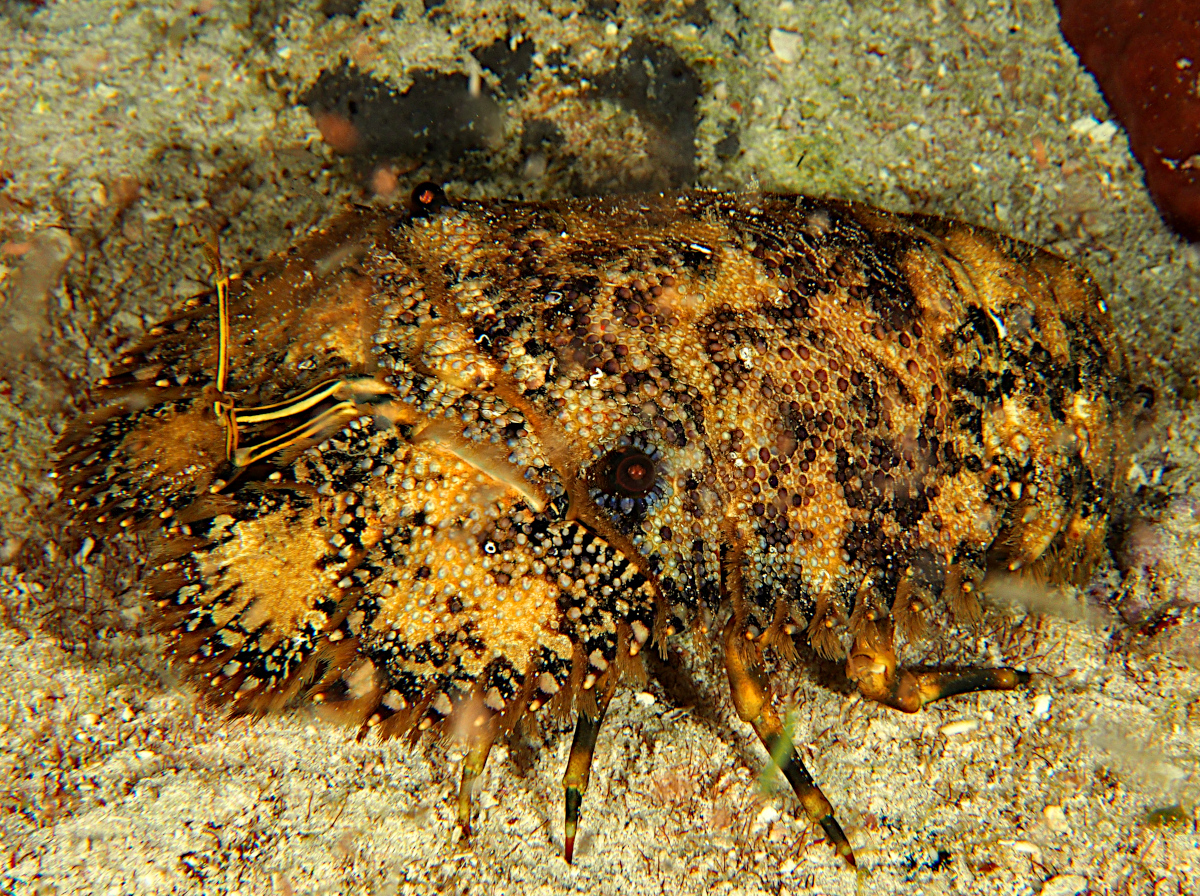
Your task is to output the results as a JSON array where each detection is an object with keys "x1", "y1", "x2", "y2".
[{"x1": 59, "y1": 190, "x2": 1130, "y2": 859}]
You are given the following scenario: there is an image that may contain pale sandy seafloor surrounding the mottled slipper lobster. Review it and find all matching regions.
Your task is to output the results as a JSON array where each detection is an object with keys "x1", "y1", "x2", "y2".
[{"x1": 0, "y1": 0, "x2": 1200, "y2": 896}]
